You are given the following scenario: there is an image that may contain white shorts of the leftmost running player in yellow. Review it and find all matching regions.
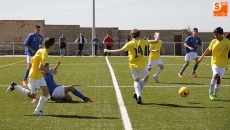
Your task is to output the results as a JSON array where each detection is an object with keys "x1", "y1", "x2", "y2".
[{"x1": 28, "y1": 77, "x2": 47, "y2": 93}]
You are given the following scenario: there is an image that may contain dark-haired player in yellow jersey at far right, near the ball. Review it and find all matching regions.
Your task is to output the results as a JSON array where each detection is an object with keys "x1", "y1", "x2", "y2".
[{"x1": 198, "y1": 27, "x2": 230, "y2": 101}]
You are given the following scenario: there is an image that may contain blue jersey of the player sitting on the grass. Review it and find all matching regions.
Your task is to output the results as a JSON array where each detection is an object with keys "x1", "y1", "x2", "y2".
[{"x1": 44, "y1": 68, "x2": 58, "y2": 95}]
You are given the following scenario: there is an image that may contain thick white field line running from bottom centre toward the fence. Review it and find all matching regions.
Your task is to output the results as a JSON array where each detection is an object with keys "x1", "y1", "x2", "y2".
[{"x1": 105, "y1": 56, "x2": 133, "y2": 130}]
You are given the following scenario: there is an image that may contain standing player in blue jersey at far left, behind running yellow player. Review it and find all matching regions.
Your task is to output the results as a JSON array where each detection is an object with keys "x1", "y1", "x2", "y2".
[{"x1": 22, "y1": 25, "x2": 43, "y2": 85}]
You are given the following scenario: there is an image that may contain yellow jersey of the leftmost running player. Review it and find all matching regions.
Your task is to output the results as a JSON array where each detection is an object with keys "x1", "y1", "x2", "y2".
[{"x1": 29, "y1": 48, "x2": 48, "y2": 80}]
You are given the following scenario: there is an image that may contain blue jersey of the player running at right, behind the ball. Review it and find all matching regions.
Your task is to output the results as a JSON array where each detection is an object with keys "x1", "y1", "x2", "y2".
[{"x1": 185, "y1": 36, "x2": 202, "y2": 54}]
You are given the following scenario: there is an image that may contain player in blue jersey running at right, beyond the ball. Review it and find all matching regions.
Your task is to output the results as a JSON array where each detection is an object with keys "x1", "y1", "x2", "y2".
[{"x1": 178, "y1": 28, "x2": 202, "y2": 77}]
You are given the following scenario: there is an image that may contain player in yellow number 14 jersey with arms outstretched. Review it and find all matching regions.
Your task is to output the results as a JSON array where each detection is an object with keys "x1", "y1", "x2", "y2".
[{"x1": 104, "y1": 29, "x2": 159, "y2": 104}]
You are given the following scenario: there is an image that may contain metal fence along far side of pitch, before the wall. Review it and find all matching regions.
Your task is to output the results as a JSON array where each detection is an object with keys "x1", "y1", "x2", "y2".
[{"x1": 0, "y1": 42, "x2": 210, "y2": 56}]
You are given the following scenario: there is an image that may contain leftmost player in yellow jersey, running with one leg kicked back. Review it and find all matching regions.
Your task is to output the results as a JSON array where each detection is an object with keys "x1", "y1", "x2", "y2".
[{"x1": 6, "y1": 38, "x2": 57, "y2": 116}]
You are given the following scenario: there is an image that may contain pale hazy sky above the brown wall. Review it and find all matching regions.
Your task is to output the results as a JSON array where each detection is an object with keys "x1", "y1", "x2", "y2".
[{"x1": 0, "y1": 0, "x2": 230, "y2": 32}]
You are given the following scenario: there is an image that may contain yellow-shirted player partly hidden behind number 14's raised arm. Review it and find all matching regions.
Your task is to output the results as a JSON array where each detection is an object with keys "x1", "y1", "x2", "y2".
[{"x1": 148, "y1": 36, "x2": 165, "y2": 83}]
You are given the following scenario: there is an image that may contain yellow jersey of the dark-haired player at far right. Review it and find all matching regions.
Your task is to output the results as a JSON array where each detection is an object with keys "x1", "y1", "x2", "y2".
[{"x1": 208, "y1": 38, "x2": 230, "y2": 68}]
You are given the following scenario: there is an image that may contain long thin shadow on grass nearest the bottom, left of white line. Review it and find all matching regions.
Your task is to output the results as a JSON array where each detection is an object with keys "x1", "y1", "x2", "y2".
[{"x1": 47, "y1": 114, "x2": 118, "y2": 119}]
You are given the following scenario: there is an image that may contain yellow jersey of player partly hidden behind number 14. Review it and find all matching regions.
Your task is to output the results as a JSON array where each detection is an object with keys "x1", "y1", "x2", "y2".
[{"x1": 149, "y1": 40, "x2": 162, "y2": 61}]
